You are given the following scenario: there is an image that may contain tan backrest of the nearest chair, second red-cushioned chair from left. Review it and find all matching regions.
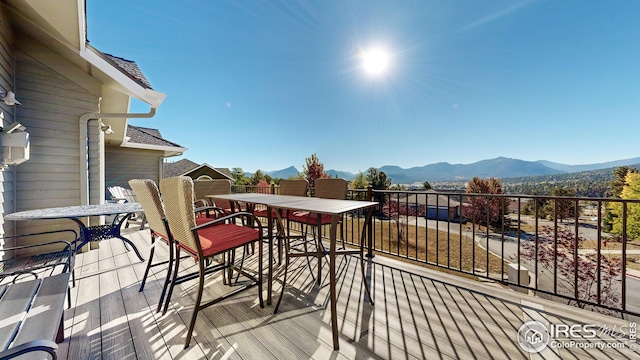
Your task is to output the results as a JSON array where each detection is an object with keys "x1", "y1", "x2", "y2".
[{"x1": 160, "y1": 176, "x2": 200, "y2": 252}]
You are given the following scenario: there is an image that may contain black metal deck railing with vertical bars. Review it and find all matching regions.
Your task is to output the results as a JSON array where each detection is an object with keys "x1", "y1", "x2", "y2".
[{"x1": 235, "y1": 186, "x2": 640, "y2": 316}]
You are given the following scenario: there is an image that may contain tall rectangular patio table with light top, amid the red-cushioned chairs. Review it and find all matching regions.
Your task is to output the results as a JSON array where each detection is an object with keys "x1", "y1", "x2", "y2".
[{"x1": 208, "y1": 193, "x2": 378, "y2": 350}]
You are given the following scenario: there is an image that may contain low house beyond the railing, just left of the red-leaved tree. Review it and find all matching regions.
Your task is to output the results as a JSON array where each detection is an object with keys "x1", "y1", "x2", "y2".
[{"x1": 383, "y1": 190, "x2": 460, "y2": 221}]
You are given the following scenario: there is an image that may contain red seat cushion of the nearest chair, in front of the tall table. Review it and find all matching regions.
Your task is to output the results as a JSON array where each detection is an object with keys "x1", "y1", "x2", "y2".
[{"x1": 180, "y1": 224, "x2": 260, "y2": 257}]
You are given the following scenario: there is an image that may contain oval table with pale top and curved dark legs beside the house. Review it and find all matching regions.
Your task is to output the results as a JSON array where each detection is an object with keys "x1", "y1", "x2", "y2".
[{"x1": 4, "y1": 203, "x2": 144, "y2": 261}]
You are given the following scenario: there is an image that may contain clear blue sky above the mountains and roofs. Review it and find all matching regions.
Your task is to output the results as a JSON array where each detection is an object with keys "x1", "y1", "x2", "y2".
[{"x1": 87, "y1": 0, "x2": 640, "y2": 173}]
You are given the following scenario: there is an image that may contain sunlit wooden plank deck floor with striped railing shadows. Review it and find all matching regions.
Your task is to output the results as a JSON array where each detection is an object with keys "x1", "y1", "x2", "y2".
[{"x1": 53, "y1": 229, "x2": 638, "y2": 360}]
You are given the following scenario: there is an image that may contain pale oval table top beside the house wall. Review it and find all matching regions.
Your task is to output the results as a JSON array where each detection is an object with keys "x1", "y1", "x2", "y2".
[{"x1": 4, "y1": 203, "x2": 142, "y2": 220}]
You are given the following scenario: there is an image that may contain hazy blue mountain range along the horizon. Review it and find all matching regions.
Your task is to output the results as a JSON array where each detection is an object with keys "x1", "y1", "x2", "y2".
[{"x1": 264, "y1": 157, "x2": 640, "y2": 184}]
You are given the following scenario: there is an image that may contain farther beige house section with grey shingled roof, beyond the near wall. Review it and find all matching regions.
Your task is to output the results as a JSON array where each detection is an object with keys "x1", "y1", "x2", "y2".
[{"x1": 105, "y1": 125, "x2": 187, "y2": 188}]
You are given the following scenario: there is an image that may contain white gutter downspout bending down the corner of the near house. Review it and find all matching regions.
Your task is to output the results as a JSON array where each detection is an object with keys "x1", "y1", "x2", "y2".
[{"x1": 79, "y1": 107, "x2": 156, "y2": 205}]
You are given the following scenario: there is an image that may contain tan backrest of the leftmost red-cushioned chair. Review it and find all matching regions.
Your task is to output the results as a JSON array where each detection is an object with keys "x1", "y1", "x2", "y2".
[{"x1": 129, "y1": 179, "x2": 168, "y2": 238}]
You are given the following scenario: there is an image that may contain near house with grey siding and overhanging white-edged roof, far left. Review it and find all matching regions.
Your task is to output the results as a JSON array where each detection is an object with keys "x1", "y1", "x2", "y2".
[{"x1": 0, "y1": 0, "x2": 168, "y2": 240}]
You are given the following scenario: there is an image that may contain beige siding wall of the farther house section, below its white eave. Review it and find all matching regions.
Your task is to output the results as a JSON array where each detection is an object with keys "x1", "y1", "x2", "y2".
[{"x1": 105, "y1": 146, "x2": 164, "y2": 188}]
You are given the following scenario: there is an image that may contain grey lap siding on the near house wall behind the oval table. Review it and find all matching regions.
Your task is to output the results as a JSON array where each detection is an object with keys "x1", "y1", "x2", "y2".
[{"x1": 8, "y1": 33, "x2": 100, "y2": 240}]
